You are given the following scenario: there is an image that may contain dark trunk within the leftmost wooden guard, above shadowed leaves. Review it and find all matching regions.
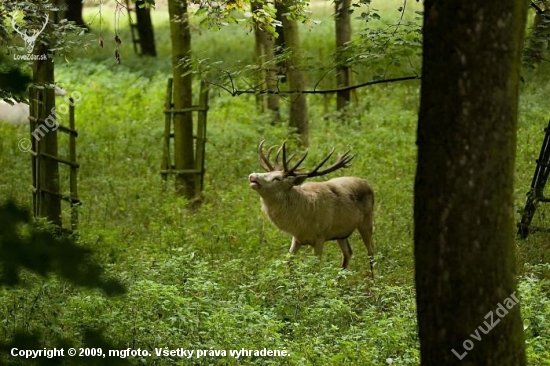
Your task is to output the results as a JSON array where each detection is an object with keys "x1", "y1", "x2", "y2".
[{"x1": 32, "y1": 2, "x2": 62, "y2": 227}]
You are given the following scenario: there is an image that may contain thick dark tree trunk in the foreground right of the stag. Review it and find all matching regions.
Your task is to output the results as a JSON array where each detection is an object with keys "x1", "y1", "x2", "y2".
[{"x1": 414, "y1": 0, "x2": 528, "y2": 366}]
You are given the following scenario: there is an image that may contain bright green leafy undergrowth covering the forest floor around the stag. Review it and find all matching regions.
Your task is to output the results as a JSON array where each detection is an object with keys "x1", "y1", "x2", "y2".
[{"x1": 0, "y1": 2, "x2": 550, "y2": 366}]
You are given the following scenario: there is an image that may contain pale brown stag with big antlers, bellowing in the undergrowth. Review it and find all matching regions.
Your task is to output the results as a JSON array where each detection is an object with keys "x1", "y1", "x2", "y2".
[{"x1": 248, "y1": 141, "x2": 374, "y2": 276}]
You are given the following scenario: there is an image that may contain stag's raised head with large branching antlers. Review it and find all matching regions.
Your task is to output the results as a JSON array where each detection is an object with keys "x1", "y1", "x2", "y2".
[{"x1": 248, "y1": 140, "x2": 353, "y2": 193}]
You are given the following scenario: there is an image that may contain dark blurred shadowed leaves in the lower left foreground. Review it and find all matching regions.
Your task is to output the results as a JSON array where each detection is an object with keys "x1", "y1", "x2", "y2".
[{"x1": 0, "y1": 201, "x2": 128, "y2": 365}]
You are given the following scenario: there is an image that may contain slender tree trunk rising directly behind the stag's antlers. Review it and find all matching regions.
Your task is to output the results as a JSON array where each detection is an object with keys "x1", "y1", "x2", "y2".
[{"x1": 277, "y1": 2, "x2": 309, "y2": 146}]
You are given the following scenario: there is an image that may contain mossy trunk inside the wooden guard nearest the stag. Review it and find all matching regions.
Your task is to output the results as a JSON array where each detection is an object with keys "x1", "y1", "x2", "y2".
[{"x1": 168, "y1": 0, "x2": 196, "y2": 199}]
